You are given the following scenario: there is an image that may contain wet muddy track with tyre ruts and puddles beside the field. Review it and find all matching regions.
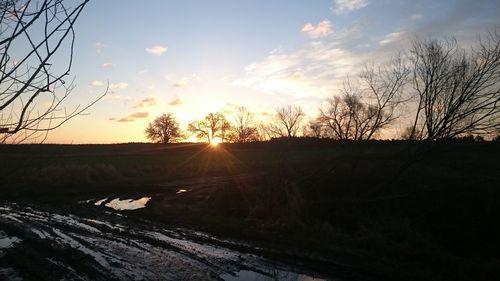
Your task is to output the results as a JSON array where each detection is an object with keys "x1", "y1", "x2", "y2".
[{"x1": 0, "y1": 201, "x2": 341, "y2": 280}]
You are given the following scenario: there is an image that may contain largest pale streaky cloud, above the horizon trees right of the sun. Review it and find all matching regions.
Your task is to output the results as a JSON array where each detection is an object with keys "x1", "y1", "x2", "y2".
[{"x1": 233, "y1": 42, "x2": 364, "y2": 97}]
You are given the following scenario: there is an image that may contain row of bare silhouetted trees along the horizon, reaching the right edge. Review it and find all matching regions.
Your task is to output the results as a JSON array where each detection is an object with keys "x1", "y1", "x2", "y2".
[{"x1": 146, "y1": 30, "x2": 500, "y2": 143}]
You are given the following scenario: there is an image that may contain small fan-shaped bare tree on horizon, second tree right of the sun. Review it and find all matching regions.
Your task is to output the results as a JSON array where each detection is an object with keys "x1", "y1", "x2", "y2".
[{"x1": 266, "y1": 105, "x2": 305, "y2": 138}]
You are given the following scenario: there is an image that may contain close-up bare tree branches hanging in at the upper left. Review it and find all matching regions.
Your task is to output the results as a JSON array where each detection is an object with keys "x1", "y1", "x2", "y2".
[{"x1": 0, "y1": 0, "x2": 102, "y2": 143}]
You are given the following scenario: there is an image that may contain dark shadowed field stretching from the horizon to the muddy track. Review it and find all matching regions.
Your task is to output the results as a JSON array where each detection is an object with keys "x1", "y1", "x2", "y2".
[{"x1": 0, "y1": 139, "x2": 500, "y2": 280}]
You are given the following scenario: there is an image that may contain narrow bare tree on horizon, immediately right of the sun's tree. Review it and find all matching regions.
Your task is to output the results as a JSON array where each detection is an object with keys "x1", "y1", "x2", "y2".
[{"x1": 232, "y1": 106, "x2": 259, "y2": 143}]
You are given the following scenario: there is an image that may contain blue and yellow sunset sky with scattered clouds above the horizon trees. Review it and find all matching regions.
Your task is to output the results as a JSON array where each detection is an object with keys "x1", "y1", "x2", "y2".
[{"x1": 35, "y1": 0, "x2": 500, "y2": 143}]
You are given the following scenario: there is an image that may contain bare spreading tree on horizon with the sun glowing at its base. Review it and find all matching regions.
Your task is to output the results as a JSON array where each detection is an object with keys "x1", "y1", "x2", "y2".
[{"x1": 188, "y1": 112, "x2": 231, "y2": 142}]
